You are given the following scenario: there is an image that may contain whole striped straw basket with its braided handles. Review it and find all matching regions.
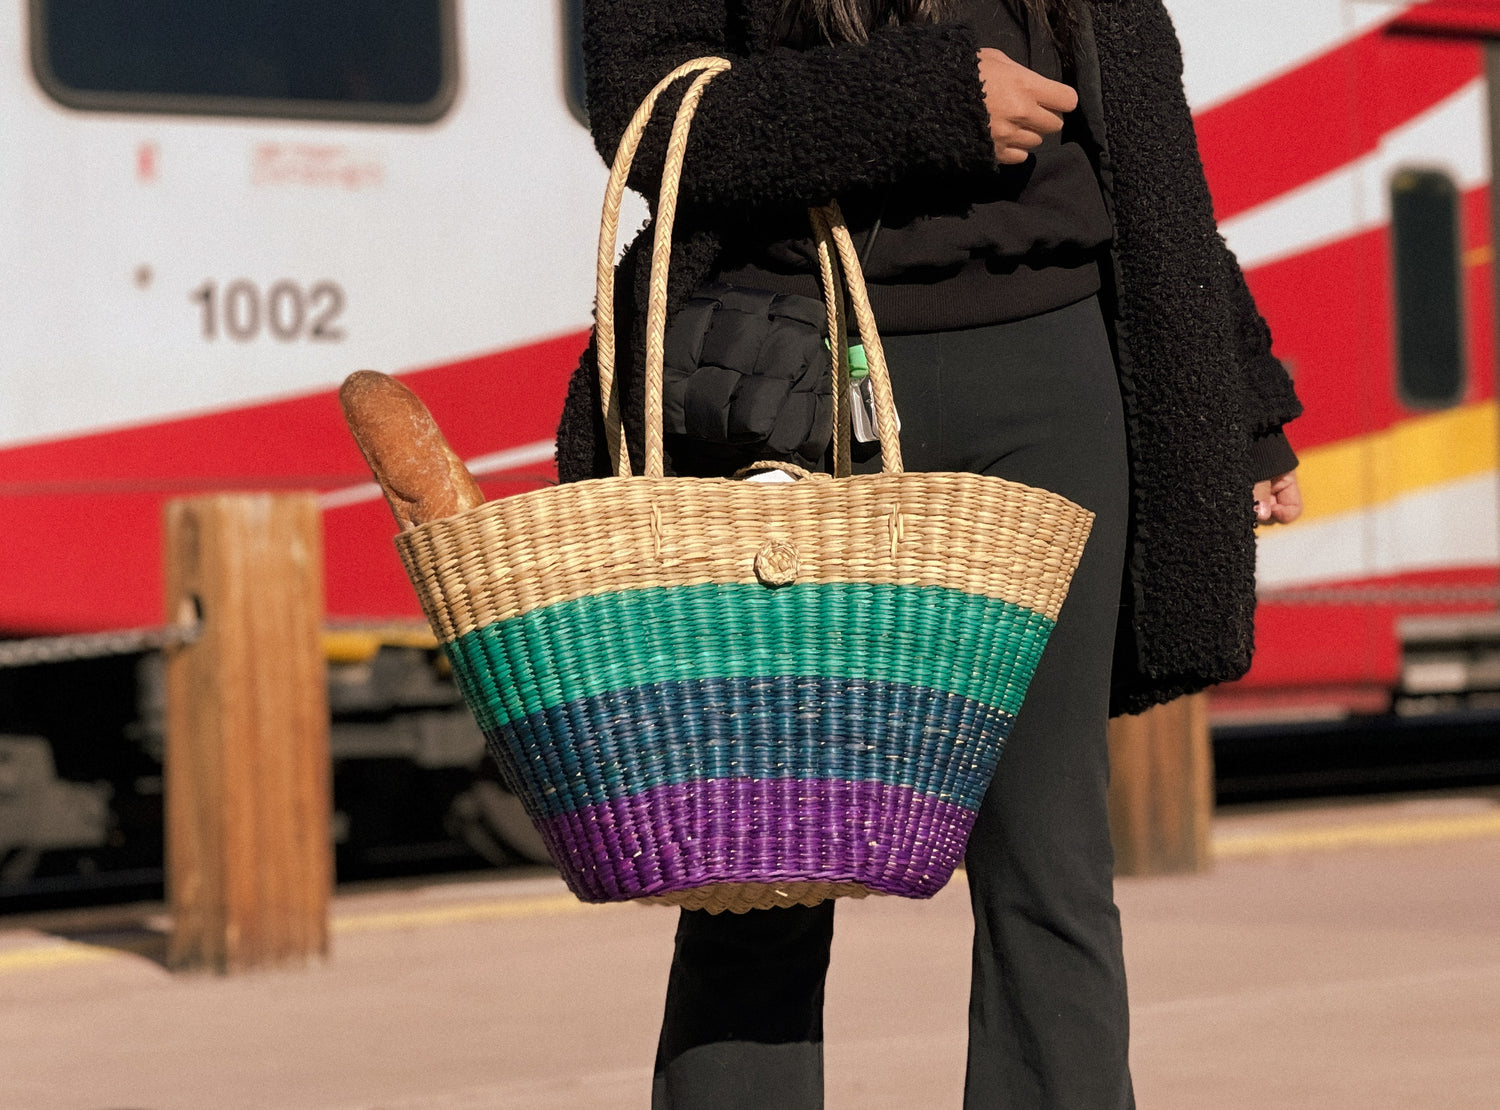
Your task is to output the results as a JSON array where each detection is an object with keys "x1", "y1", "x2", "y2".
[{"x1": 398, "y1": 59, "x2": 1092, "y2": 911}]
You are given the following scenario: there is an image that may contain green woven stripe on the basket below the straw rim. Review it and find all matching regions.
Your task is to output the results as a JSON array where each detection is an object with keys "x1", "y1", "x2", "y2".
[{"x1": 447, "y1": 582, "x2": 1053, "y2": 729}]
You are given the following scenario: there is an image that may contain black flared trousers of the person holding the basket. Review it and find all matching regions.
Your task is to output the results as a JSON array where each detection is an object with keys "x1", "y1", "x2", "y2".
[{"x1": 653, "y1": 299, "x2": 1134, "y2": 1110}]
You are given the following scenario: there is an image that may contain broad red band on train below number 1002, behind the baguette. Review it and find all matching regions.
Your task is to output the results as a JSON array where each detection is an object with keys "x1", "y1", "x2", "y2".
[{"x1": 0, "y1": 335, "x2": 587, "y2": 633}]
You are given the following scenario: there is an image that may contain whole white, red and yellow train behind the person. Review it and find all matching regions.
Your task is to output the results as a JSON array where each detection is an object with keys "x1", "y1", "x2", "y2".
[{"x1": 0, "y1": 0, "x2": 1500, "y2": 899}]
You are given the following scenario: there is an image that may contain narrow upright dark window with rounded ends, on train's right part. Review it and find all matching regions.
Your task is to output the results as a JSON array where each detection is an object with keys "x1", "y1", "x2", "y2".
[{"x1": 1391, "y1": 170, "x2": 1464, "y2": 408}]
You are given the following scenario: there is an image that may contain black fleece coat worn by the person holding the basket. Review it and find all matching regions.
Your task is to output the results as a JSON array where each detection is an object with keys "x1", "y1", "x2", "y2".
[{"x1": 558, "y1": 0, "x2": 1301, "y2": 713}]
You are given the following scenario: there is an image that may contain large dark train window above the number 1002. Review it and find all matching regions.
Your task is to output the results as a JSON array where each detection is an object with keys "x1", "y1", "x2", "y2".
[{"x1": 30, "y1": 0, "x2": 458, "y2": 123}]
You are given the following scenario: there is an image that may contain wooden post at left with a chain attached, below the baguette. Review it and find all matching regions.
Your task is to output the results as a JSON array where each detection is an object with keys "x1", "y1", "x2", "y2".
[{"x1": 165, "y1": 495, "x2": 333, "y2": 972}]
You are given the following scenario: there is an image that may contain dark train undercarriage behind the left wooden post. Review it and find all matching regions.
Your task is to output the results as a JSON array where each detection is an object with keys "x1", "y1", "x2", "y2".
[{"x1": 0, "y1": 633, "x2": 548, "y2": 912}]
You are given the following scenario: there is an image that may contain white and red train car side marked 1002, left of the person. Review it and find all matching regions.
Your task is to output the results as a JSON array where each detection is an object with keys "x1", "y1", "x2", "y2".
[{"x1": 0, "y1": 0, "x2": 605, "y2": 635}]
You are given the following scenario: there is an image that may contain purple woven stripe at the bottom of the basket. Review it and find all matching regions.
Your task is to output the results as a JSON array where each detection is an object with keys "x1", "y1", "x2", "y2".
[{"x1": 537, "y1": 779, "x2": 975, "y2": 902}]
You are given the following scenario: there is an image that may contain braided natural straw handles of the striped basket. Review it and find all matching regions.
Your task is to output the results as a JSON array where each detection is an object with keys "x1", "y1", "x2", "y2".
[{"x1": 594, "y1": 57, "x2": 902, "y2": 479}]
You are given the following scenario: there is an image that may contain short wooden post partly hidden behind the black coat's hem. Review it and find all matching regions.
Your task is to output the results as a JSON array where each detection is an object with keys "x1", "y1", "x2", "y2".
[{"x1": 1110, "y1": 695, "x2": 1214, "y2": 875}]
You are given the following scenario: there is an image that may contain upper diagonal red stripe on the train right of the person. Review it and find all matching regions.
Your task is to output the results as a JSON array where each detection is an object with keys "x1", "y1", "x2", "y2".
[{"x1": 1194, "y1": 27, "x2": 1484, "y2": 219}]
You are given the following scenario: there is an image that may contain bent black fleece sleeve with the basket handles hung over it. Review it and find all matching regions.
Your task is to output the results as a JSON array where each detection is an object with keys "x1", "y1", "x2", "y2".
[{"x1": 584, "y1": 0, "x2": 995, "y2": 213}]
